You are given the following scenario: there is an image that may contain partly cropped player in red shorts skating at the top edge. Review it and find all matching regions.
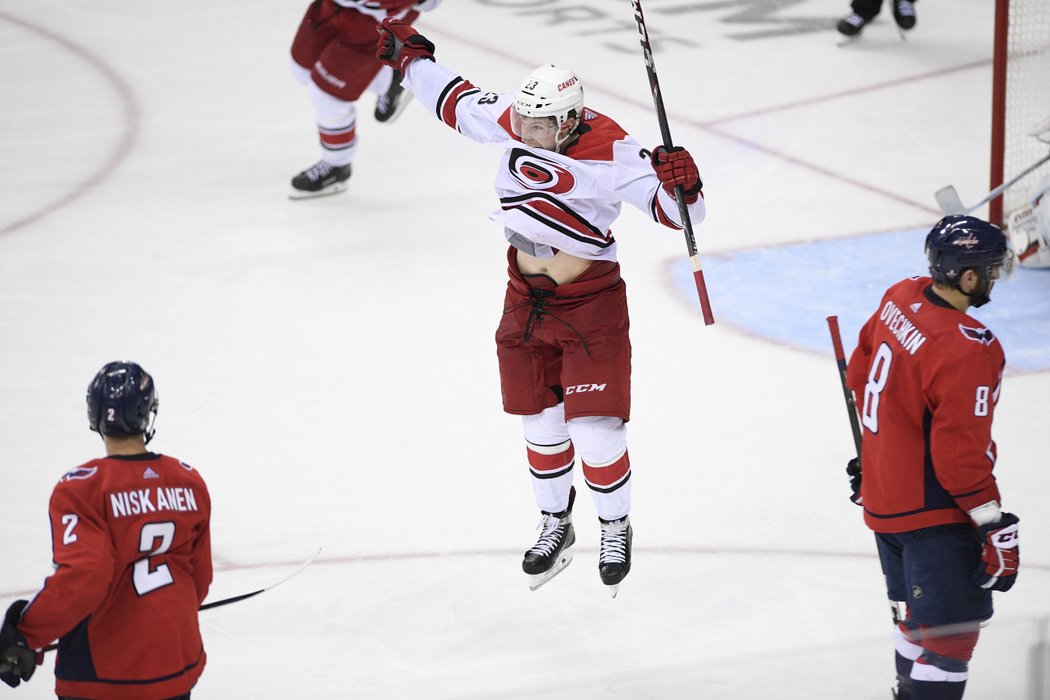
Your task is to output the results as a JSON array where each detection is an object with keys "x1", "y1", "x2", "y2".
[{"x1": 290, "y1": 0, "x2": 441, "y2": 199}]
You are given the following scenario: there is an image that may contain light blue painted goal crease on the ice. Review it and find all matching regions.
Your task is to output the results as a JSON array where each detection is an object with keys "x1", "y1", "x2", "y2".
[{"x1": 673, "y1": 229, "x2": 1050, "y2": 372}]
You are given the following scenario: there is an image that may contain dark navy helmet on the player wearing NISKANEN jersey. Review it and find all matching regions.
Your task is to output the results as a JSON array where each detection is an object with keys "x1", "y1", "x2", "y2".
[{"x1": 87, "y1": 362, "x2": 160, "y2": 443}]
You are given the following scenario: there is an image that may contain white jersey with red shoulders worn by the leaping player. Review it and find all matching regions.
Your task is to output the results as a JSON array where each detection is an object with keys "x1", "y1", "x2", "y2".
[{"x1": 404, "y1": 60, "x2": 705, "y2": 260}]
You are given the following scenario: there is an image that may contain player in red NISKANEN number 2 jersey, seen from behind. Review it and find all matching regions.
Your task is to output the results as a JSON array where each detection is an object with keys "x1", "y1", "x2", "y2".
[{"x1": 0, "y1": 362, "x2": 212, "y2": 700}]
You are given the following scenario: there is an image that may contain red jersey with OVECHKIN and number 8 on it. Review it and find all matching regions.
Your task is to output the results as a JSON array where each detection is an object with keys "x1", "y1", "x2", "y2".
[{"x1": 847, "y1": 277, "x2": 1005, "y2": 532}]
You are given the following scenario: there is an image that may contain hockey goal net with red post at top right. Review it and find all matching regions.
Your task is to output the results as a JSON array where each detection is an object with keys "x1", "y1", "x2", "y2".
[{"x1": 989, "y1": 0, "x2": 1050, "y2": 225}]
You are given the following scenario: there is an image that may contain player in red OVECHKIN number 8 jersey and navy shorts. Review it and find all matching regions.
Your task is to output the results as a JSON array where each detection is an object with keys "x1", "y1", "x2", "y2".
[{"x1": 847, "y1": 216, "x2": 1020, "y2": 700}]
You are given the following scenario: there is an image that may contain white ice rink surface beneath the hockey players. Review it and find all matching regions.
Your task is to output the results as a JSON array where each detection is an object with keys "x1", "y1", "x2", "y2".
[{"x1": 0, "y1": 0, "x2": 1050, "y2": 700}]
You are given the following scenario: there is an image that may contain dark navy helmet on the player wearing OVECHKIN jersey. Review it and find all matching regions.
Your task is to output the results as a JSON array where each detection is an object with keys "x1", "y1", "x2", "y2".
[{"x1": 926, "y1": 215, "x2": 1013, "y2": 306}]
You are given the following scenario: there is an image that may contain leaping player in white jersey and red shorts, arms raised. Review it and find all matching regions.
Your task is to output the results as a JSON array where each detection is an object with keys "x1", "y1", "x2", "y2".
[{"x1": 377, "y1": 19, "x2": 705, "y2": 595}]
